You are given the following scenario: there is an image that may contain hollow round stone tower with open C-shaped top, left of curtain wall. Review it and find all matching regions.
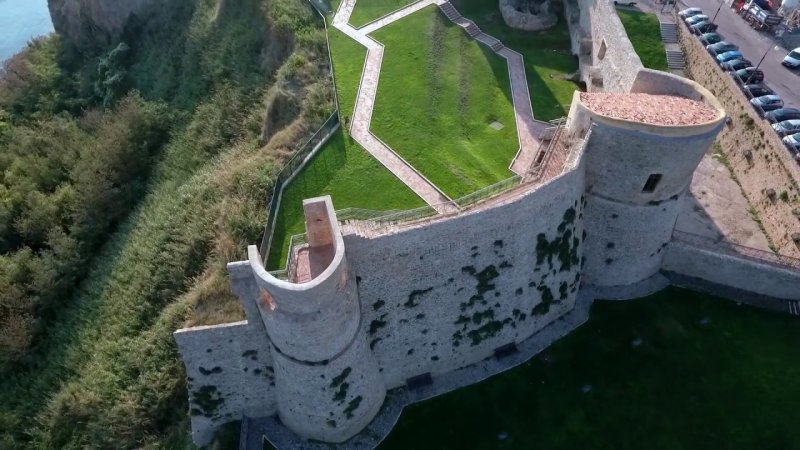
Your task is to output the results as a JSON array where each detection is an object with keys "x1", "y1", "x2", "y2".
[{"x1": 248, "y1": 197, "x2": 386, "y2": 442}]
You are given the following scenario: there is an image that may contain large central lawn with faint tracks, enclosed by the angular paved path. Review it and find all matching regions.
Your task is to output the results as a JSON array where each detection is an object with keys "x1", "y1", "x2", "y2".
[{"x1": 372, "y1": 6, "x2": 519, "y2": 198}]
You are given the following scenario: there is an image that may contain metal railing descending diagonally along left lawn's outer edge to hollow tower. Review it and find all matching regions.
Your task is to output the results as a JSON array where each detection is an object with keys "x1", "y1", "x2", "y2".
[{"x1": 260, "y1": 111, "x2": 339, "y2": 264}]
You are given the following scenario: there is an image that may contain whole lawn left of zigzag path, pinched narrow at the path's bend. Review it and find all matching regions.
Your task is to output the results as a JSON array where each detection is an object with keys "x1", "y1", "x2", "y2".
[{"x1": 267, "y1": 27, "x2": 424, "y2": 269}]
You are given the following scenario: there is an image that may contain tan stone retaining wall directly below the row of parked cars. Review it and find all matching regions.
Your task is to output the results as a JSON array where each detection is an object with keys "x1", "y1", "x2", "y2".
[{"x1": 678, "y1": 21, "x2": 800, "y2": 257}]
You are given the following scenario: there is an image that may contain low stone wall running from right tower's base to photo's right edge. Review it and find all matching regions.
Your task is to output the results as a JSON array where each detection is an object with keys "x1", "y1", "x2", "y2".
[{"x1": 663, "y1": 241, "x2": 800, "y2": 300}]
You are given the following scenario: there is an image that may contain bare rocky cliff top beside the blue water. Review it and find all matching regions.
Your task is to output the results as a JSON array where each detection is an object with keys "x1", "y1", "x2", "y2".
[{"x1": 47, "y1": 0, "x2": 165, "y2": 47}]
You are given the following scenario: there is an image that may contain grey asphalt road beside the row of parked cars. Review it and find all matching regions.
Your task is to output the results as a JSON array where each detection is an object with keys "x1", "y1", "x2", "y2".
[{"x1": 679, "y1": 0, "x2": 800, "y2": 108}]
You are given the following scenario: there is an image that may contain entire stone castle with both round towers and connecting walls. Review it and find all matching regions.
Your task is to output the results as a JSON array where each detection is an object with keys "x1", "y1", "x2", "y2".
[{"x1": 175, "y1": 2, "x2": 800, "y2": 448}]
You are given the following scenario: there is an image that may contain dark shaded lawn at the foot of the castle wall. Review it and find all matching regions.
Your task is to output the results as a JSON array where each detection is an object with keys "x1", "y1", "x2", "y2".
[{"x1": 380, "y1": 288, "x2": 800, "y2": 450}]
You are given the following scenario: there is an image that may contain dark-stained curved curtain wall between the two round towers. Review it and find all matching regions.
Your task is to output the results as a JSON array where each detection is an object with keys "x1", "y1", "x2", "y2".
[{"x1": 345, "y1": 159, "x2": 583, "y2": 388}]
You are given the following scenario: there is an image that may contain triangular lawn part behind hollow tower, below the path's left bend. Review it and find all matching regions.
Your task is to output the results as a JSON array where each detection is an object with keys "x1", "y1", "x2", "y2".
[{"x1": 267, "y1": 129, "x2": 425, "y2": 270}]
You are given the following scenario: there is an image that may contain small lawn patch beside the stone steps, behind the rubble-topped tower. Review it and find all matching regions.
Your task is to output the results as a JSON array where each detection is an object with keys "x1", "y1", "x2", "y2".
[{"x1": 617, "y1": 9, "x2": 668, "y2": 70}]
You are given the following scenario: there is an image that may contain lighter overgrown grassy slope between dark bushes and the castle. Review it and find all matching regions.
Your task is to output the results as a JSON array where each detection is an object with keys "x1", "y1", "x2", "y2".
[{"x1": 0, "y1": 0, "x2": 330, "y2": 449}]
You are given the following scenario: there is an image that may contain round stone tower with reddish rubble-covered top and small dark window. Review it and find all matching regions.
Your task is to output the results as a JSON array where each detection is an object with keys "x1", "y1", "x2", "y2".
[{"x1": 567, "y1": 69, "x2": 725, "y2": 286}]
